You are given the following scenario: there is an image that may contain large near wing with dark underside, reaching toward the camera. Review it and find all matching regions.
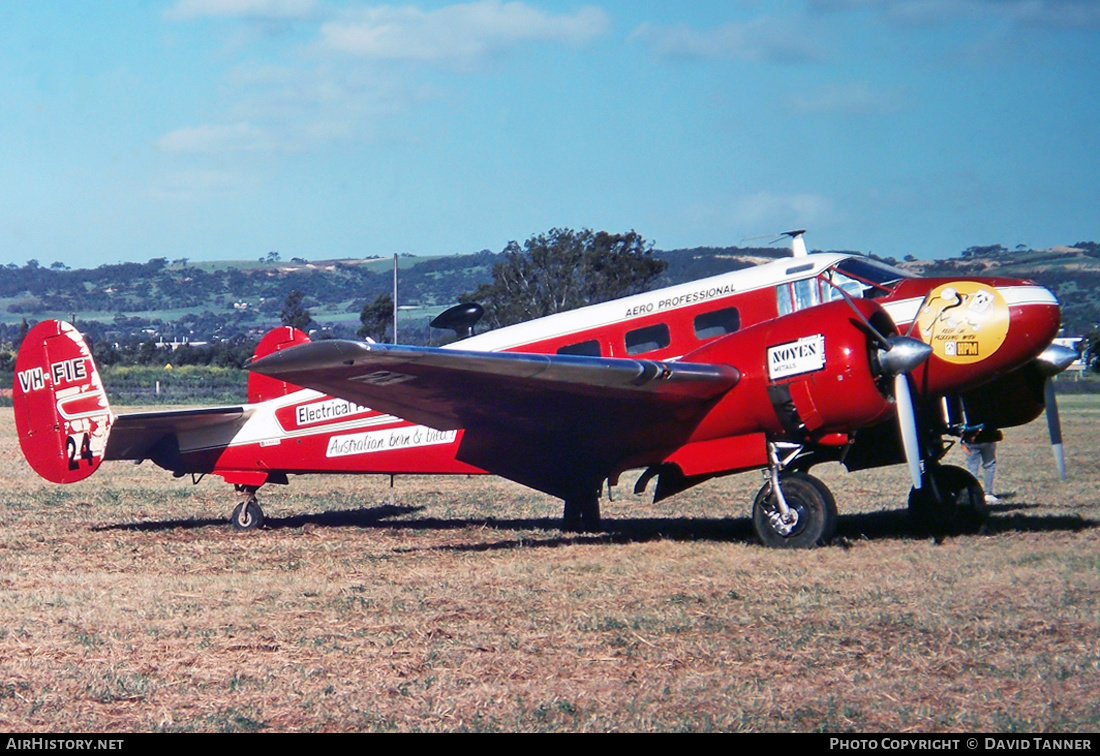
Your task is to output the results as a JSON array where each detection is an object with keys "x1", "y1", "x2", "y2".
[{"x1": 250, "y1": 340, "x2": 740, "y2": 495}]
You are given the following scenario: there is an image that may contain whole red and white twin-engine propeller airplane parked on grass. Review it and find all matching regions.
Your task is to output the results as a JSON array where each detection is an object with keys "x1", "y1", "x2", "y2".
[{"x1": 13, "y1": 232, "x2": 1076, "y2": 548}]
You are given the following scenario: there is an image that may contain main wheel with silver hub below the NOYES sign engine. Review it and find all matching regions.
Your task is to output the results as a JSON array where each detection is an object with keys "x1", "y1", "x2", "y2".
[{"x1": 752, "y1": 471, "x2": 836, "y2": 549}]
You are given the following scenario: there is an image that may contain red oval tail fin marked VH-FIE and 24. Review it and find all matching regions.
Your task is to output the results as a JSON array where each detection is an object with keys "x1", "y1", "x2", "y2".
[{"x1": 12, "y1": 320, "x2": 114, "y2": 483}]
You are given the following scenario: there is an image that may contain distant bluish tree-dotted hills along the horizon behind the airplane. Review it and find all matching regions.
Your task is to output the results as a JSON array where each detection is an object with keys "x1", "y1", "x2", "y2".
[{"x1": 0, "y1": 242, "x2": 1100, "y2": 342}]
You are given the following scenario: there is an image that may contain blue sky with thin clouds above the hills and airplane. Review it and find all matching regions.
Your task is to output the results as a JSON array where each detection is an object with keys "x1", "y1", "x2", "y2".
[{"x1": 0, "y1": 0, "x2": 1100, "y2": 267}]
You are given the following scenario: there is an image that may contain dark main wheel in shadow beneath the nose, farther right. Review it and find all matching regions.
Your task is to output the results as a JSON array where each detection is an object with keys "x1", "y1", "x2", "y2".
[{"x1": 909, "y1": 464, "x2": 989, "y2": 535}]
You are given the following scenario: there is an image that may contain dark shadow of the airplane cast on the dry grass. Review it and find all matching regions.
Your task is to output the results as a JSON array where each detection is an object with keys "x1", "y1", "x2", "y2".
[{"x1": 91, "y1": 502, "x2": 1100, "y2": 551}]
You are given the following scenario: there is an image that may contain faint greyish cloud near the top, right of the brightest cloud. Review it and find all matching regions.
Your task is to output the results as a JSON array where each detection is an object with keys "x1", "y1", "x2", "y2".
[{"x1": 631, "y1": 18, "x2": 822, "y2": 63}]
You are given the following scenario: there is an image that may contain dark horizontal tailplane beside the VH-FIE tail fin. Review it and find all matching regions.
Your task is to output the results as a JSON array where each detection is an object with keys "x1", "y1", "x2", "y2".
[{"x1": 103, "y1": 407, "x2": 248, "y2": 464}]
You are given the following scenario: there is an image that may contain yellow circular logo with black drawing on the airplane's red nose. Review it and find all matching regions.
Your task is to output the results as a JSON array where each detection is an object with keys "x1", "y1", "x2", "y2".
[{"x1": 916, "y1": 281, "x2": 1009, "y2": 365}]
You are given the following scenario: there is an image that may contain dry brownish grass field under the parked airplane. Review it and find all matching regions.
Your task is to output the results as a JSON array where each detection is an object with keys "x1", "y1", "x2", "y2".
[{"x1": 0, "y1": 397, "x2": 1100, "y2": 732}]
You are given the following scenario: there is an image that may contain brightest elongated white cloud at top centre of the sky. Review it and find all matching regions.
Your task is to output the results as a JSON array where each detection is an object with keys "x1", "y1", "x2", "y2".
[{"x1": 321, "y1": 0, "x2": 611, "y2": 64}]
